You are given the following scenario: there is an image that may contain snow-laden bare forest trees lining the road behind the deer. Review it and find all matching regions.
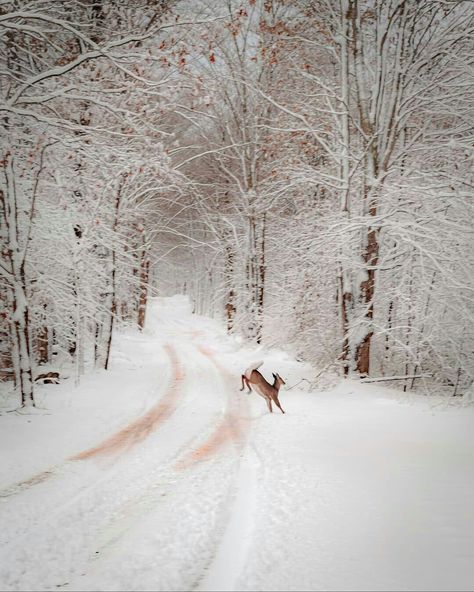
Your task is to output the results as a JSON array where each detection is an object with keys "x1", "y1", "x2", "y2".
[{"x1": 0, "y1": 0, "x2": 474, "y2": 406}]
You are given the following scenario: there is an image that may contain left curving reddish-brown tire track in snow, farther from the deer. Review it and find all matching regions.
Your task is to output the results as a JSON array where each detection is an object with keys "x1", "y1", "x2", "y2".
[{"x1": 0, "y1": 344, "x2": 184, "y2": 498}]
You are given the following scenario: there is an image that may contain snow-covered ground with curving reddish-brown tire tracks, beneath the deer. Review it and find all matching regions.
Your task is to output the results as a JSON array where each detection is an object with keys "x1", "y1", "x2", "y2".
[{"x1": 0, "y1": 297, "x2": 474, "y2": 590}]
